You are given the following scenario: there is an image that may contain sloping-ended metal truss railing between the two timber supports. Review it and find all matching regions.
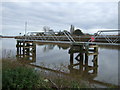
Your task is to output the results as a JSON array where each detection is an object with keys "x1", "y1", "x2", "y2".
[{"x1": 21, "y1": 31, "x2": 75, "y2": 42}]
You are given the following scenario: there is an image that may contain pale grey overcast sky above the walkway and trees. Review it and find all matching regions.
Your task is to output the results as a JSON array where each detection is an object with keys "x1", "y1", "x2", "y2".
[{"x1": 2, "y1": 2, "x2": 118, "y2": 35}]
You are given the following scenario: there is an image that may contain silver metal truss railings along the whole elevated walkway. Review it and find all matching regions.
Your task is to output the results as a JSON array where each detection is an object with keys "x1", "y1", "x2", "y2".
[{"x1": 17, "y1": 30, "x2": 120, "y2": 45}]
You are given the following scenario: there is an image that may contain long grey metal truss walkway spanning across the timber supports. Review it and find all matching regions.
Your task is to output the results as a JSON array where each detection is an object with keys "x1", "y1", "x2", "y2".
[{"x1": 18, "y1": 30, "x2": 120, "y2": 46}]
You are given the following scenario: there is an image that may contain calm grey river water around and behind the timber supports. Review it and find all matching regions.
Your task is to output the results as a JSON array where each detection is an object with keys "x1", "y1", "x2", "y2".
[{"x1": 0, "y1": 38, "x2": 120, "y2": 85}]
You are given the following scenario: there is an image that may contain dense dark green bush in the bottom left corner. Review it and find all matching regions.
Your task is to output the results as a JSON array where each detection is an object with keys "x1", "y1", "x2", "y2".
[{"x1": 2, "y1": 62, "x2": 39, "y2": 89}]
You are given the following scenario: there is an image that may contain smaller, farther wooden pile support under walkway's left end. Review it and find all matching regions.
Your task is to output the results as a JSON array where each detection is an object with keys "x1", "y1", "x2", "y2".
[{"x1": 16, "y1": 41, "x2": 36, "y2": 61}]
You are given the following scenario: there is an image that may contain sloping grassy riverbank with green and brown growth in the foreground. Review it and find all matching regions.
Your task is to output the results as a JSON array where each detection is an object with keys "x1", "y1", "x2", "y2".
[{"x1": 2, "y1": 59, "x2": 88, "y2": 90}]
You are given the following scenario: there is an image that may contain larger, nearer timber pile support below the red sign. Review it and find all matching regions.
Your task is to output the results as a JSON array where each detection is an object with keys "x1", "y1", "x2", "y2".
[{"x1": 69, "y1": 44, "x2": 98, "y2": 75}]
